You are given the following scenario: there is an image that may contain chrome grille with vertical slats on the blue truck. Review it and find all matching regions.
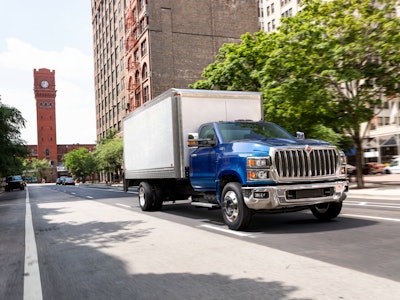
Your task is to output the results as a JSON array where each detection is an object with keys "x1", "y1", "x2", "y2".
[{"x1": 273, "y1": 147, "x2": 340, "y2": 179}]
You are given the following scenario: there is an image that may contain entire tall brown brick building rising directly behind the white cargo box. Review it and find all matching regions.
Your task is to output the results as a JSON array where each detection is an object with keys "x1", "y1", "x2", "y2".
[{"x1": 92, "y1": 0, "x2": 259, "y2": 139}]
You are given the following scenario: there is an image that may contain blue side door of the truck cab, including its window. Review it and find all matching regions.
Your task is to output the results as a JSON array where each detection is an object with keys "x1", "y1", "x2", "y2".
[{"x1": 190, "y1": 125, "x2": 217, "y2": 191}]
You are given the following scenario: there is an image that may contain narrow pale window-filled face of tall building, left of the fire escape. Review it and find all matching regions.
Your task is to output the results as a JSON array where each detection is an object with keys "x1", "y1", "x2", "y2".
[{"x1": 91, "y1": 0, "x2": 127, "y2": 140}]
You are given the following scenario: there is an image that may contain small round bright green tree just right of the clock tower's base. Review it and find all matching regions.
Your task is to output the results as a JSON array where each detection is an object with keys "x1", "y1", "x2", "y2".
[{"x1": 63, "y1": 148, "x2": 96, "y2": 180}]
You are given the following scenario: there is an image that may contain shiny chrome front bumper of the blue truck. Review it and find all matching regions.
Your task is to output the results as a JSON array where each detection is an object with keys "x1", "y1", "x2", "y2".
[{"x1": 242, "y1": 180, "x2": 348, "y2": 210}]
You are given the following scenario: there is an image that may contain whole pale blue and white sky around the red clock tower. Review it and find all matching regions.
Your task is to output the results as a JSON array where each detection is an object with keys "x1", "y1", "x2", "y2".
[{"x1": 0, "y1": 0, "x2": 96, "y2": 145}]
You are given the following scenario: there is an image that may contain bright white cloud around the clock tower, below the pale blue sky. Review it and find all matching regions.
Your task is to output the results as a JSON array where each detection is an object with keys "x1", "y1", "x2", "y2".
[{"x1": 0, "y1": 38, "x2": 96, "y2": 144}]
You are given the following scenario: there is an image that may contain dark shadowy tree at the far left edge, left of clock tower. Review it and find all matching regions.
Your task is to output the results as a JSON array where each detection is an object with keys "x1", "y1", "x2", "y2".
[{"x1": 0, "y1": 102, "x2": 28, "y2": 177}]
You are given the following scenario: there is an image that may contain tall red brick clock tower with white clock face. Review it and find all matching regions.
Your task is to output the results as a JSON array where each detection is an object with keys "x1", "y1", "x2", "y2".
[{"x1": 33, "y1": 69, "x2": 58, "y2": 167}]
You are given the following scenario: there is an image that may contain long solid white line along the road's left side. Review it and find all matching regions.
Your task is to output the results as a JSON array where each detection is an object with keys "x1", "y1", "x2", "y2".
[{"x1": 24, "y1": 188, "x2": 43, "y2": 300}]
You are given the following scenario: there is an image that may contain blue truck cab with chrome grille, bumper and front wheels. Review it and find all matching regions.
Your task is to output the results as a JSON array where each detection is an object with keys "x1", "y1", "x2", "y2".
[{"x1": 188, "y1": 121, "x2": 348, "y2": 230}]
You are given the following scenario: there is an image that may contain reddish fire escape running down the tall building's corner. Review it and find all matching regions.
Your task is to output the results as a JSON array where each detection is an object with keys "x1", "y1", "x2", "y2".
[{"x1": 125, "y1": 7, "x2": 140, "y2": 111}]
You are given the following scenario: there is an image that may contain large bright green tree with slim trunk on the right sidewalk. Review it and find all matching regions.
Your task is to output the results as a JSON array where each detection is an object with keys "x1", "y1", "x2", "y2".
[{"x1": 264, "y1": 0, "x2": 400, "y2": 187}]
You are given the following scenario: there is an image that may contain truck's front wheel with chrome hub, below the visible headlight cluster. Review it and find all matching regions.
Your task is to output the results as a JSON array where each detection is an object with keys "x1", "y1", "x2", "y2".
[{"x1": 221, "y1": 182, "x2": 252, "y2": 230}]
